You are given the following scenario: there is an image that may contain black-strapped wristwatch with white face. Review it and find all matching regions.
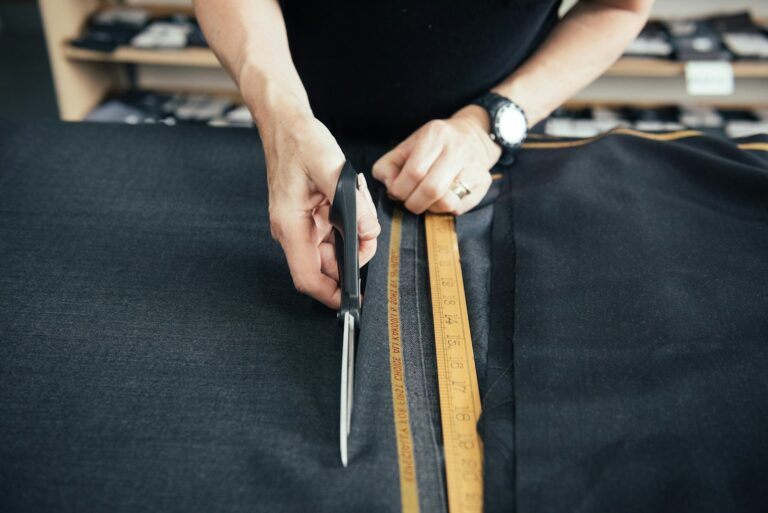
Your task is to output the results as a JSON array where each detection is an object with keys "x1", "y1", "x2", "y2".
[{"x1": 472, "y1": 93, "x2": 528, "y2": 166}]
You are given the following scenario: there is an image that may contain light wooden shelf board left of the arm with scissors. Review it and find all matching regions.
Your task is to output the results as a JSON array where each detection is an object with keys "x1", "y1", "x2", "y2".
[{"x1": 63, "y1": 43, "x2": 221, "y2": 68}]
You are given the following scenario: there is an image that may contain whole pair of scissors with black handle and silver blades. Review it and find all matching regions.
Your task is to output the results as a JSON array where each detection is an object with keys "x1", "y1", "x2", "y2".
[{"x1": 329, "y1": 161, "x2": 360, "y2": 467}]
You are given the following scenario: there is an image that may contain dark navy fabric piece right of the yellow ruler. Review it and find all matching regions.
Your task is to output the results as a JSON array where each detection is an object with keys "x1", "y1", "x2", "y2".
[{"x1": 481, "y1": 133, "x2": 768, "y2": 513}]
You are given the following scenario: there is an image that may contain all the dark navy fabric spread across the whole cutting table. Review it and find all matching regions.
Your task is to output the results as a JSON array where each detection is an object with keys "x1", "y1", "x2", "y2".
[{"x1": 0, "y1": 123, "x2": 768, "y2": 513}]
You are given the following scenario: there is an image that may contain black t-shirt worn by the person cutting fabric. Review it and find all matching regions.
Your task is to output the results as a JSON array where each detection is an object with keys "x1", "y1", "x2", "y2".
[{"x1": 282, "y1": 0, "x2": 560, "y2": 138}]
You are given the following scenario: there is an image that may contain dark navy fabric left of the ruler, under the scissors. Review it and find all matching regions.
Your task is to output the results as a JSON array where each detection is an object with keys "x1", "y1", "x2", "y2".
[{"x1": 0, "y1": 123, "x2": 492, "y2": 512}]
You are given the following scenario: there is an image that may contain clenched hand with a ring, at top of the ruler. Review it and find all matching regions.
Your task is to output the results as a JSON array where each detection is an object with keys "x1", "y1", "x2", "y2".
[{"x1": 373, "y1": 105, "x2": 501, "y2": 215}]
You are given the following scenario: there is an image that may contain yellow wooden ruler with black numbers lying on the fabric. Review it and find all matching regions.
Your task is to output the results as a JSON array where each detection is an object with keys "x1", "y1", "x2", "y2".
[{"x1": 424, "y1": 210, "x2": 483, "y2": 513}]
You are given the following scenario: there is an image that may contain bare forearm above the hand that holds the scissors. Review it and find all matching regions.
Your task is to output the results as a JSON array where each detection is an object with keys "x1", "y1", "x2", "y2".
[{"x1": 194, "y1": 0, "x2": 311, "y2": 135}]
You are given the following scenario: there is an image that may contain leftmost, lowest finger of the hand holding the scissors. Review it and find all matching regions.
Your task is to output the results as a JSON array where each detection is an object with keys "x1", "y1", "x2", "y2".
[{"x1": 279, "y1": 213, "x2": 341, "y2": 309}]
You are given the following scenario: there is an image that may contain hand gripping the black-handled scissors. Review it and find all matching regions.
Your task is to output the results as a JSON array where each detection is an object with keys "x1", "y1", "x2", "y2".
[{"x1": 259, "y1": 108, "x2": 381, "y2": 309}]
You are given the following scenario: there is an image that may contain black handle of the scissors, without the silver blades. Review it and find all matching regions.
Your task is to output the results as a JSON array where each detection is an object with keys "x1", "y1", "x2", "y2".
[{"x1": 329, "y1": 161, "x2": 360, "y2": 326}]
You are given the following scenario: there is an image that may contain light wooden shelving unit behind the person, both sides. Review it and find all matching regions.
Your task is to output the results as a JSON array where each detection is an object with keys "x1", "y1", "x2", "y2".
[{"x1": 38, "y1": 0, "x2": 768, "y2": 120}]
